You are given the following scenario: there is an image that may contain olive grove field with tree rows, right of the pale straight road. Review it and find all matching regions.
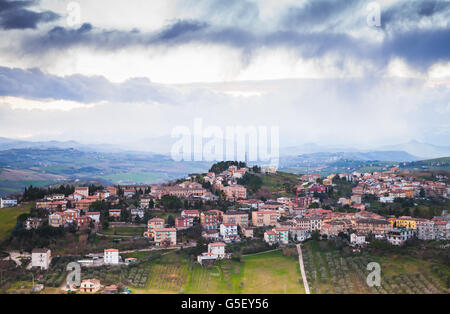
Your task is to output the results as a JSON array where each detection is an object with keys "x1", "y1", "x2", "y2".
[{"x1": 303, "y1": 241, "x2": 450, "y2": 294}]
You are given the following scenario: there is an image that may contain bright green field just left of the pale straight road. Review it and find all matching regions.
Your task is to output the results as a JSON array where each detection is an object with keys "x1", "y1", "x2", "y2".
[{"x1": 132, "y1": 251, "x2": 304, "y2": 294}]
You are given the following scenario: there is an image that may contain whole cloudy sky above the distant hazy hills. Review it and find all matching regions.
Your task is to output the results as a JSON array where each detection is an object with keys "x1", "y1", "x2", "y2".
[{"x1": 0, "y1": 0, "x2": 450, "y2": 150}]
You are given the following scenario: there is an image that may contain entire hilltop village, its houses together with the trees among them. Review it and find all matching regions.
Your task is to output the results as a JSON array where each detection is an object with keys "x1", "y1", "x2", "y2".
[{"x1": 0, "y1": 162, "x2": 450, "y2": 293}]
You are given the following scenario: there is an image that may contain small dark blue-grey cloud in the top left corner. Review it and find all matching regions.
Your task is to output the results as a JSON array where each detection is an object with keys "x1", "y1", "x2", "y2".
[{"x1": 0, "y1": 0, "x2": 59, "y2": 30}]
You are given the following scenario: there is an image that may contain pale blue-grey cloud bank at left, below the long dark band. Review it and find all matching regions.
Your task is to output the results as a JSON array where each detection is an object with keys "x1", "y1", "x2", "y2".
[{"x1": 0, "y1": 67, "x2": 185, "y2": 104}]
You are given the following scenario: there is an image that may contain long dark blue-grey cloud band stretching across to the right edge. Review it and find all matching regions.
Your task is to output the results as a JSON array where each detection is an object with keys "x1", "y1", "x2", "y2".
[{"x1": 10, "y1": 0, "x2": 450, "y2": 70}]
